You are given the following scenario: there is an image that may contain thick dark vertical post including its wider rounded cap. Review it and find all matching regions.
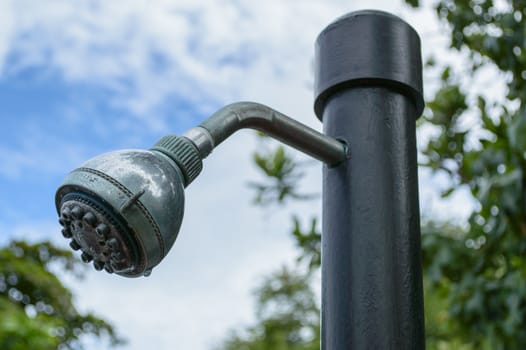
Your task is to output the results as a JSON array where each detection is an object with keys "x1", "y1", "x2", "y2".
[{"x1": 315, "y1": 11, "x2": 425, "y2": 350}]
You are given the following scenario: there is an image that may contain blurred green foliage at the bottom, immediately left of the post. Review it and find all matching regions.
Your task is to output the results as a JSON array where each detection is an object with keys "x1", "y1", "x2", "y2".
[{"x1": 218, "y1": 267, "x2": 320, "y2": 350}]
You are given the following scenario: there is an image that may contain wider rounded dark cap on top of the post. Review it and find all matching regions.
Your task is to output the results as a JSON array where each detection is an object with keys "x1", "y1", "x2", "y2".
[{"x1": 314, "y1": 10, "x2": 424, "y2": 120}]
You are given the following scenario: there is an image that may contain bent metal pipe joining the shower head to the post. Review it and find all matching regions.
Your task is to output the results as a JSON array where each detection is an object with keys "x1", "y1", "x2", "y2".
[{"x1": 182, "y1": 102, "x2": 349, "y2": 166}]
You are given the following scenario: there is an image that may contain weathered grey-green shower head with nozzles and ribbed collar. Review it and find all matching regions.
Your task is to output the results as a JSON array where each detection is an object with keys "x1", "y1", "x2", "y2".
[{"x1": 55, "y1": 136, "x2": 202, "y2": 277}]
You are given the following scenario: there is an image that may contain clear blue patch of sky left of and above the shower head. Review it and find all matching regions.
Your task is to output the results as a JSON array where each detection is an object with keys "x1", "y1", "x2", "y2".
[{"x1": 0, "y1": 63, "x2": 211, "y2": 245}]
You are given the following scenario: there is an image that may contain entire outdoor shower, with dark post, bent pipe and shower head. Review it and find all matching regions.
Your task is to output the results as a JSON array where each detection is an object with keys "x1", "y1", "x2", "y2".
[{"x1": 55, "y1": 11, "x2": 425, "y2": 350}]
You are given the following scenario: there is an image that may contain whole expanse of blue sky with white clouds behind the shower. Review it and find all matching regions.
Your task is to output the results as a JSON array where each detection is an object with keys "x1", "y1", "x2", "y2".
[{"x1": 0, "y1": 0, "x2": 474, "y2": 350}]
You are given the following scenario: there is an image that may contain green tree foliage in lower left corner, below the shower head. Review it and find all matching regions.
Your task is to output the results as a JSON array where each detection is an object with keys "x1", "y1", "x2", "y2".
[{"x1": 0, "y1": 241, "x2": 123, "y2": 350}]
